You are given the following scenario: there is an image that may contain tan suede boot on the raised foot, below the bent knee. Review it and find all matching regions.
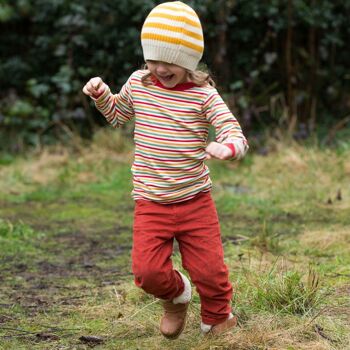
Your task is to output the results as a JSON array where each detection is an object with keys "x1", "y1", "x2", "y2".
[{"x1": 160, "y1": 301, "x2": 189, "y2": 339}]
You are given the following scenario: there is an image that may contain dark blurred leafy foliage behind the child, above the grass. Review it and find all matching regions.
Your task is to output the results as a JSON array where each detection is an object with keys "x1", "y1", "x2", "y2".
[{"x1": 0, "y1": 0, "x2": 350, "y2": 150}]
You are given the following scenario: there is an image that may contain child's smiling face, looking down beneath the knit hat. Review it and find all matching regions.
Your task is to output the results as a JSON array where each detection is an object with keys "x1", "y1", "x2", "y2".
[{"x1": 146, "y1": 60, "x2": 187, "y2": 88}]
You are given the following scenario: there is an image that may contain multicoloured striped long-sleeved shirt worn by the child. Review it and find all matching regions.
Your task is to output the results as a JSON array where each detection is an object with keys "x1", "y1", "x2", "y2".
[{"x1": 95, "y1": 70, "x2": 248, "y2": 203}]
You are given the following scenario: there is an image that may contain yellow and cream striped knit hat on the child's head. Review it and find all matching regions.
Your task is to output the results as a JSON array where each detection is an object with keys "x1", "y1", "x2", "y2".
[{"x1": 141, "y1": 1, "x2": 204, "y2": 71}]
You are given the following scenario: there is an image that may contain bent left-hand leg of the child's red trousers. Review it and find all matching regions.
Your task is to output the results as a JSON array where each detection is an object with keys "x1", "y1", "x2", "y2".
[{"x1": 132, "y1": 200, "x2": 184, "y2": 300}]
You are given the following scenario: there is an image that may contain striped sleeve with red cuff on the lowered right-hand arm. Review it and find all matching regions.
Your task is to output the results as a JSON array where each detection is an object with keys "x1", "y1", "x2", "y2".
[{"x1": 203, "y1": 89, "x2": 249, "y2": 159}]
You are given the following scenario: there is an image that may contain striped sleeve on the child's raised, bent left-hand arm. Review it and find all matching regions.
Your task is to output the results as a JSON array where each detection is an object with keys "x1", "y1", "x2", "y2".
[{"x1": 92, "y1": 76, "x2": 135, "y2": 128}]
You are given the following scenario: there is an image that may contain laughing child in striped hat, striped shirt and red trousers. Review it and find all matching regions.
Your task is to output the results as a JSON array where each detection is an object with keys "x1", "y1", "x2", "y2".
[{"x1": 83, "y1": 1, "x2": 248, "y2": 339}]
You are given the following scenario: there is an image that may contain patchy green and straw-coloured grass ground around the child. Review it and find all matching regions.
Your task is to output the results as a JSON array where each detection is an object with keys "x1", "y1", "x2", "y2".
[{"x1": 0, "y1": 131, "x2": 350, "y2": 350}]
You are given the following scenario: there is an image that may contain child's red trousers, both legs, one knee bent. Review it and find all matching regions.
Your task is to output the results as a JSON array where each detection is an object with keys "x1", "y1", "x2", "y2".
[{"x1": 132, "y1": 192, "x2": 232, "y2": 325}]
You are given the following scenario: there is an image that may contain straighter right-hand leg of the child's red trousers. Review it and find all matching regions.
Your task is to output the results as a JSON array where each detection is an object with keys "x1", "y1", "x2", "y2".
[{"x1": 176, "y1": 193, "x2": 232, "y2": 325}]
